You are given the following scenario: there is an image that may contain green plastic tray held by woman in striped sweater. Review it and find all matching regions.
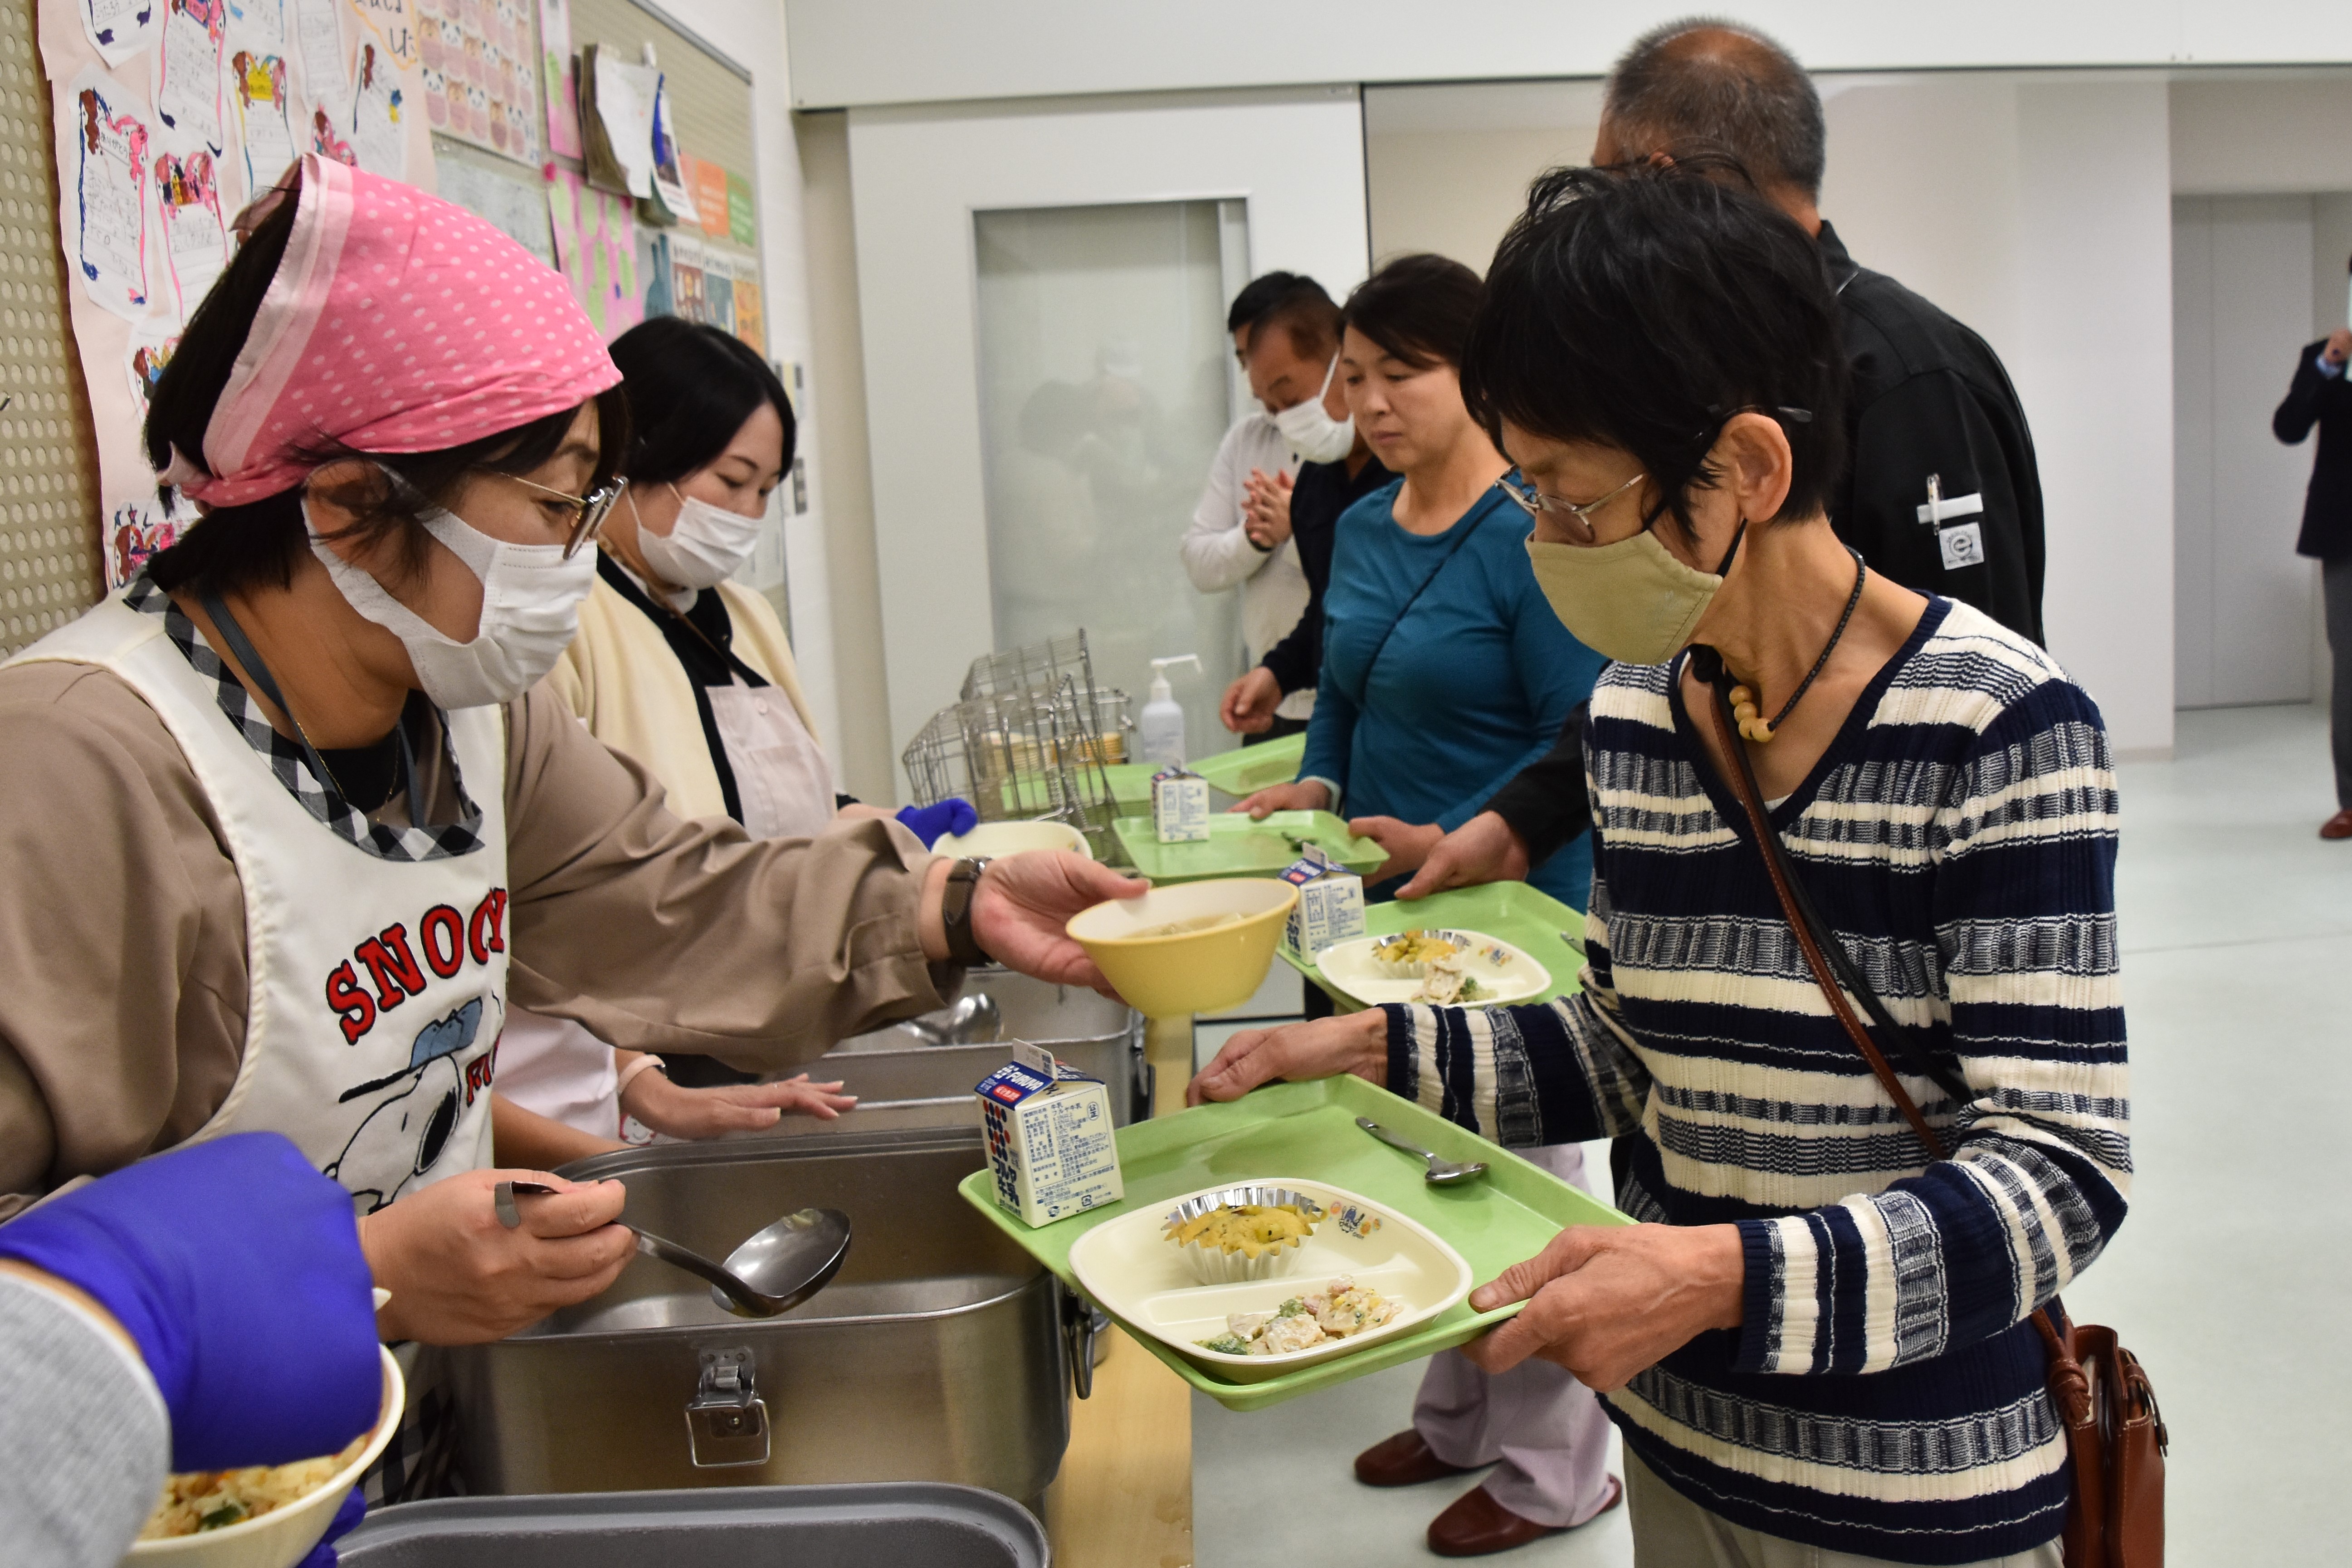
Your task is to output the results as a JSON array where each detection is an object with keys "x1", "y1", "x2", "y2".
[{"x1": 957, "y1": 1077, "x2": 1632, "y2": 1411}]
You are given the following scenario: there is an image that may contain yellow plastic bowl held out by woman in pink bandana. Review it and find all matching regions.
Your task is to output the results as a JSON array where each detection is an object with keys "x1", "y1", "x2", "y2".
[{"x1": 1068, "y1": 877, "x2": 1298, "y2": 1018}]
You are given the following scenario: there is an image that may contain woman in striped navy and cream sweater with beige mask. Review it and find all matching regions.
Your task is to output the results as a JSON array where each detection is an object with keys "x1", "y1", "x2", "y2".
[{"x1": 1192, "y1": 157, "x2": 2131, "y2": 1568}]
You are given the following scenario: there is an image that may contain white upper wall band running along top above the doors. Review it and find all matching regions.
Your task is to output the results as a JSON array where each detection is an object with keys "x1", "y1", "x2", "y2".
[{"x1": 786, "y1": 0, "x2": 2352, "y2": 108}]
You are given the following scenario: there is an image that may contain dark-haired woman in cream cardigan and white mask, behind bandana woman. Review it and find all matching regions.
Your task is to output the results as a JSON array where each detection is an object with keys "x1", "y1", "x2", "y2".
[{"x1": 498, "y1": 318, "x2": 884, "y2": 1138}]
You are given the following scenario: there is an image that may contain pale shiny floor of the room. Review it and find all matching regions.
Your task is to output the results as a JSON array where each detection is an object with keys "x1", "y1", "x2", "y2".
[{"x1": 1192, "y1": 708, "x2": 2352, "y2": 1568}]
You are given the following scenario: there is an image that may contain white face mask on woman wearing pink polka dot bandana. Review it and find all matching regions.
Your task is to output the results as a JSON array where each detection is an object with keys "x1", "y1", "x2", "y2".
[{"x1": 303, "y1": 503, "x2": 595, "y2": 708}]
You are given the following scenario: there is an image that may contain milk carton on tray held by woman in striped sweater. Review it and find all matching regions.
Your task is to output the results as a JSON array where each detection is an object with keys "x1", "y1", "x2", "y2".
[{"x1": 974, "y1": 1044, "x2": 1127, "y2": 1225}]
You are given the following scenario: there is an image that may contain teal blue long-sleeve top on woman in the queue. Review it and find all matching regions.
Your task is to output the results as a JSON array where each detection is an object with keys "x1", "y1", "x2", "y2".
[{"x1": 1298, "y1": 479, "x2": 1602, "y2": 910}]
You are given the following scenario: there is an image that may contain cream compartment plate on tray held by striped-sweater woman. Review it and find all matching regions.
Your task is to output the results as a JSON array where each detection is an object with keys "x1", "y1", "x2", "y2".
[{"x1": 1070, "y1": 1175, "x2": 1472, "y2": 1382}]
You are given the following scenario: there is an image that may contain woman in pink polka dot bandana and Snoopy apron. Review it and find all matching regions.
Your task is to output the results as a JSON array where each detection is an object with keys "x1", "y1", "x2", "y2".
[{"x1": 0, "y1": 157, "x2": 1131, "y2": 1485}]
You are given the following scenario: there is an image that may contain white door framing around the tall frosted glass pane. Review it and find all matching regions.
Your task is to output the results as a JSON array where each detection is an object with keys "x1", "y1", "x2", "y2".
[{"x1": 849, "y1": 89, "x2": 1366, "y2": 762}]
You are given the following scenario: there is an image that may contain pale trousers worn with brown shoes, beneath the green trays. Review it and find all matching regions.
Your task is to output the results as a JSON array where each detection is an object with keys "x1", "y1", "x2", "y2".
[{"x1": 1414, "y1": 1143, "x2": 1611, "y2": 1528}]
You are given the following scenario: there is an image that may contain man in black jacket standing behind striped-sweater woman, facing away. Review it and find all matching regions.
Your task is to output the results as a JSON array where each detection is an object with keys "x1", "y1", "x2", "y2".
[{"x1": 1374, "y1": 19, "x2": 2051, "y2": 898}]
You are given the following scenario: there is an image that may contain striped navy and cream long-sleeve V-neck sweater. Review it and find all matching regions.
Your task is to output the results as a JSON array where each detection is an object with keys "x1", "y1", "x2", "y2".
[{"x1": 1390, "y1": 600, "x2": 2131, "y2": 1563}]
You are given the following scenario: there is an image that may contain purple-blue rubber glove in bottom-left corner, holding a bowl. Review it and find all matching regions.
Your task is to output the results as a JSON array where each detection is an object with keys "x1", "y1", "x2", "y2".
[{"x1": 0, "y1": 1133, "x2": 383, "y2": 1472}]
